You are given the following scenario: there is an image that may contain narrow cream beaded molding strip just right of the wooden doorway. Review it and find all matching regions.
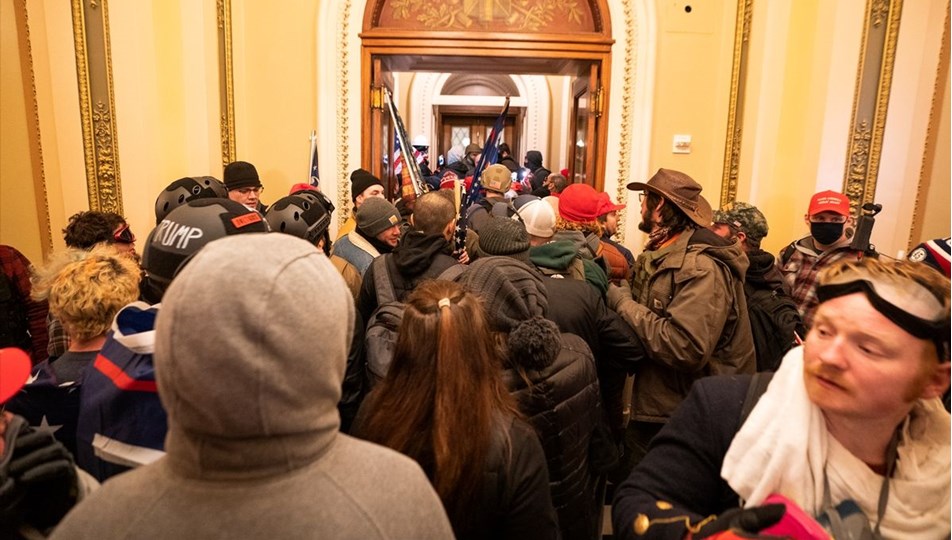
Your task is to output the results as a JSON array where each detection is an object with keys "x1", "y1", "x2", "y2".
[{"x1": 615, "y1": 2, "x2": 636, "y2": 242}]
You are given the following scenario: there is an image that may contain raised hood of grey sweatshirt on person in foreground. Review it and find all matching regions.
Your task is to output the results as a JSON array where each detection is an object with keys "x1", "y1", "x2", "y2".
[{"x1": 155, "y1": 234, "x2": 354, "y2": 480}]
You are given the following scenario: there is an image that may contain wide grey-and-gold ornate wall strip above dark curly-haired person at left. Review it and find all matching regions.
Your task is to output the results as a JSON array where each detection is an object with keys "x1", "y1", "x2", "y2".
[{"x1": 71, "y1": 0, "x2": 122, "y2": 214}]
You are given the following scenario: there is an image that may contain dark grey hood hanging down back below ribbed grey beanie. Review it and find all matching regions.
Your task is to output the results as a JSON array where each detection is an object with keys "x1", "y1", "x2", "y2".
[{"x1": 458, "y1": 257, "x2": 549, "y2": 333}]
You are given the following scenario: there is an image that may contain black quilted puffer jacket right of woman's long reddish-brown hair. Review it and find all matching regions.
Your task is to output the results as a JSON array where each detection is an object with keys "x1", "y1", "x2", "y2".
[{"x1": 504, "y1": 320, "x2": 604, "y2": 540}]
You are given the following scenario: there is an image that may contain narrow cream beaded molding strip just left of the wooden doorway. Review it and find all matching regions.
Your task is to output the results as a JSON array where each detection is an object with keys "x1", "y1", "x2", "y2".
[{"x1": 337, "y1": 0, "x2": 351, "y2": 227}]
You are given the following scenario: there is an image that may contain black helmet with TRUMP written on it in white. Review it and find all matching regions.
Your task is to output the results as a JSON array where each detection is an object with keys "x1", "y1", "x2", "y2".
[{"x1": 142, "y1": 198, "x2": 269, "y2": 303}]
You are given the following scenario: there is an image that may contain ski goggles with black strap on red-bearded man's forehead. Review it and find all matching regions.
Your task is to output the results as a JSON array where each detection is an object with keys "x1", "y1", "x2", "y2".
[{"x1": 816, "y1": 268, "x2": 950, "y2": 360}]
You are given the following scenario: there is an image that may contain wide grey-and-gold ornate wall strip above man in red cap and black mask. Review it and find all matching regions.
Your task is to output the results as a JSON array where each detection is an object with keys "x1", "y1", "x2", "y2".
[{"x1": 843, "y1": 0, "x2": 902, "y2": 215}]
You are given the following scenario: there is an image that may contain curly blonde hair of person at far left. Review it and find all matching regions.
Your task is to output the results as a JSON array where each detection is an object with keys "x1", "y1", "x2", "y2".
[{"x1": 47, "y1": 248, "x2": 140, "y2": 341}]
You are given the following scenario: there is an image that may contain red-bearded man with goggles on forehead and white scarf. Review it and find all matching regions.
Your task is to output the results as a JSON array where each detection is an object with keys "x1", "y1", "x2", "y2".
[{"x1": 613, "y1": 259, "x2": 950, "y2": 538}]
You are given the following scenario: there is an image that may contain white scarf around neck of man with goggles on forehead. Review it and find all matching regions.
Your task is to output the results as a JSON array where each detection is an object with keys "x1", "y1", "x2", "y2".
[{"x1": 721, "y1": 347, "x2": 950, "y2": 538}]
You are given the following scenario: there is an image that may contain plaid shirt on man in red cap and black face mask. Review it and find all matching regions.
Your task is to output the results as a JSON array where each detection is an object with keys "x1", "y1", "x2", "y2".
[{"x1": 777, "y1": 236, "x2": 863, "y2": 331}]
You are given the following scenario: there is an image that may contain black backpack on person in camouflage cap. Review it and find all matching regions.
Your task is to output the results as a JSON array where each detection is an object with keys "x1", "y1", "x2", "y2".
[{"x1": 744, "y1": 283, "x2": 804, "y2": 371}]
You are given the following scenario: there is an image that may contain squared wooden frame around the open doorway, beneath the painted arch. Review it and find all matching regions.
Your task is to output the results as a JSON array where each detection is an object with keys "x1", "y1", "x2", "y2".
[{"x1": 360, "y1": 40, "x2": 613, "y2": 189}]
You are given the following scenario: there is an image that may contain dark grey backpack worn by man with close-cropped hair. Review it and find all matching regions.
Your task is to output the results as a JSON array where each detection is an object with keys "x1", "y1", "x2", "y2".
[{"x1": 364, "y1": 256, "x2": 466, "y2": 387}]
